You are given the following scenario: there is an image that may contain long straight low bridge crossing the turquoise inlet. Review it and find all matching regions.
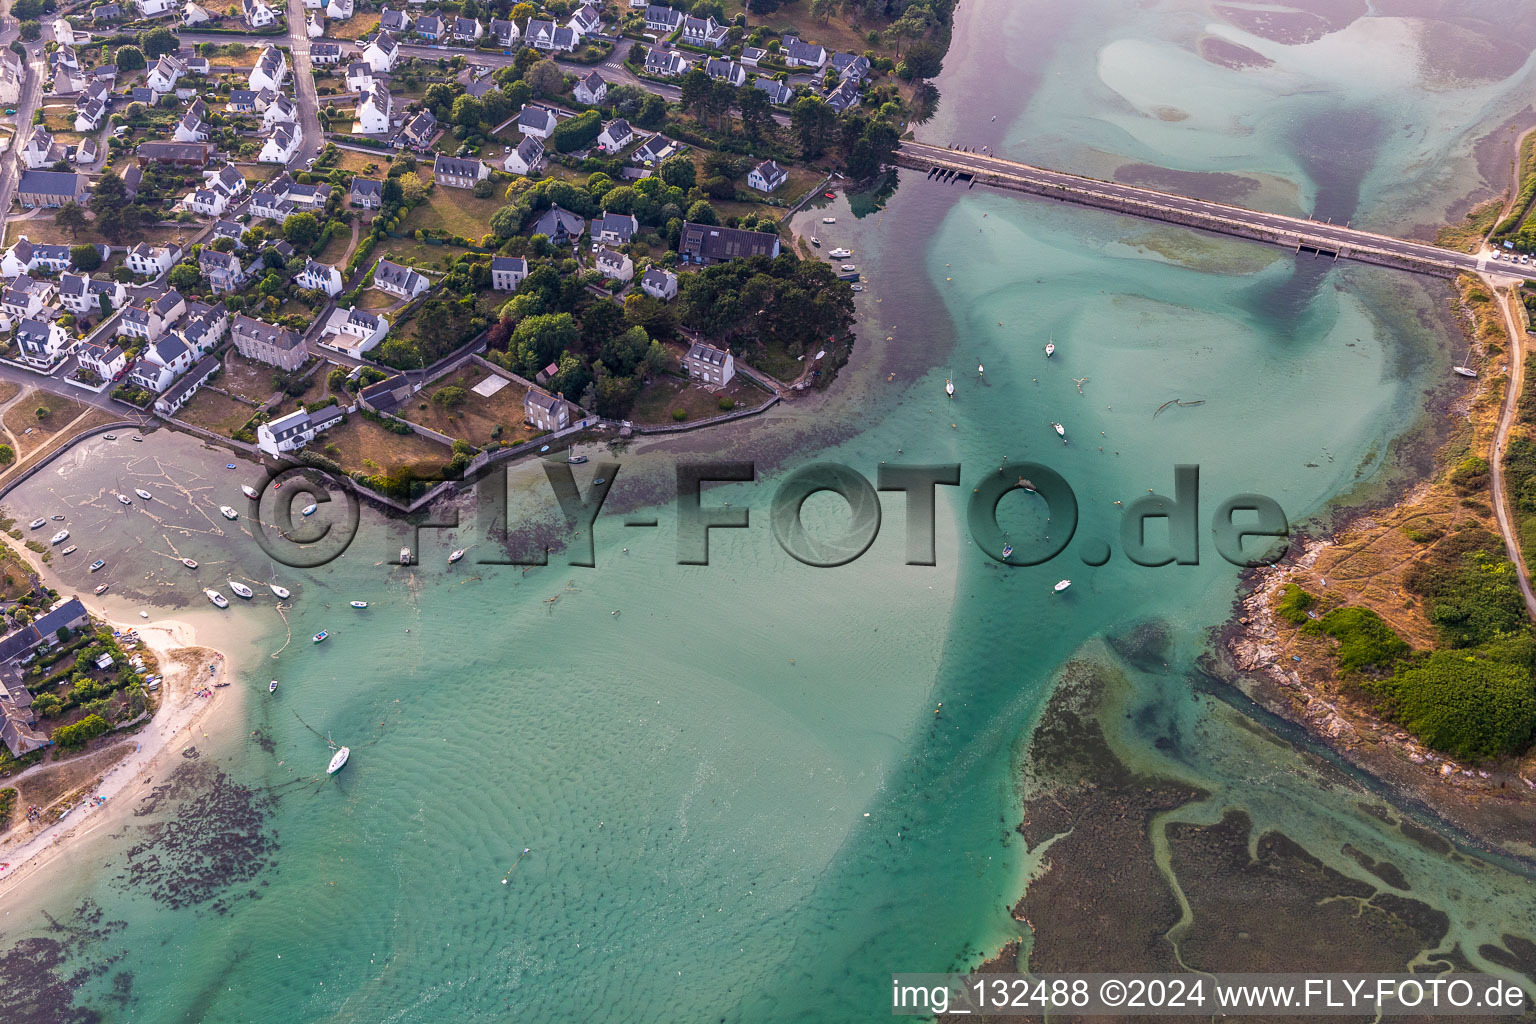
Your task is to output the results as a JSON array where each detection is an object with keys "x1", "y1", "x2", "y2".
[{"x1": 895, "y1": 140, "x2": 1536, "y2": 279}]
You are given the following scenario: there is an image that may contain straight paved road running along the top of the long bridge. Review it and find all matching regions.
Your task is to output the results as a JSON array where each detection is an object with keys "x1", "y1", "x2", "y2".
[{"x1": 897, "y1": 141, "x2": 1536, "y2": 279}]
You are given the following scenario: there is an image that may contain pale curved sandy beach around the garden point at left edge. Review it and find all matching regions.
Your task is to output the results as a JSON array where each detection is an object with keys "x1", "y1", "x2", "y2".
[{"x1": 0, "y1": 599, "x2": 240, "y2": 897}]
